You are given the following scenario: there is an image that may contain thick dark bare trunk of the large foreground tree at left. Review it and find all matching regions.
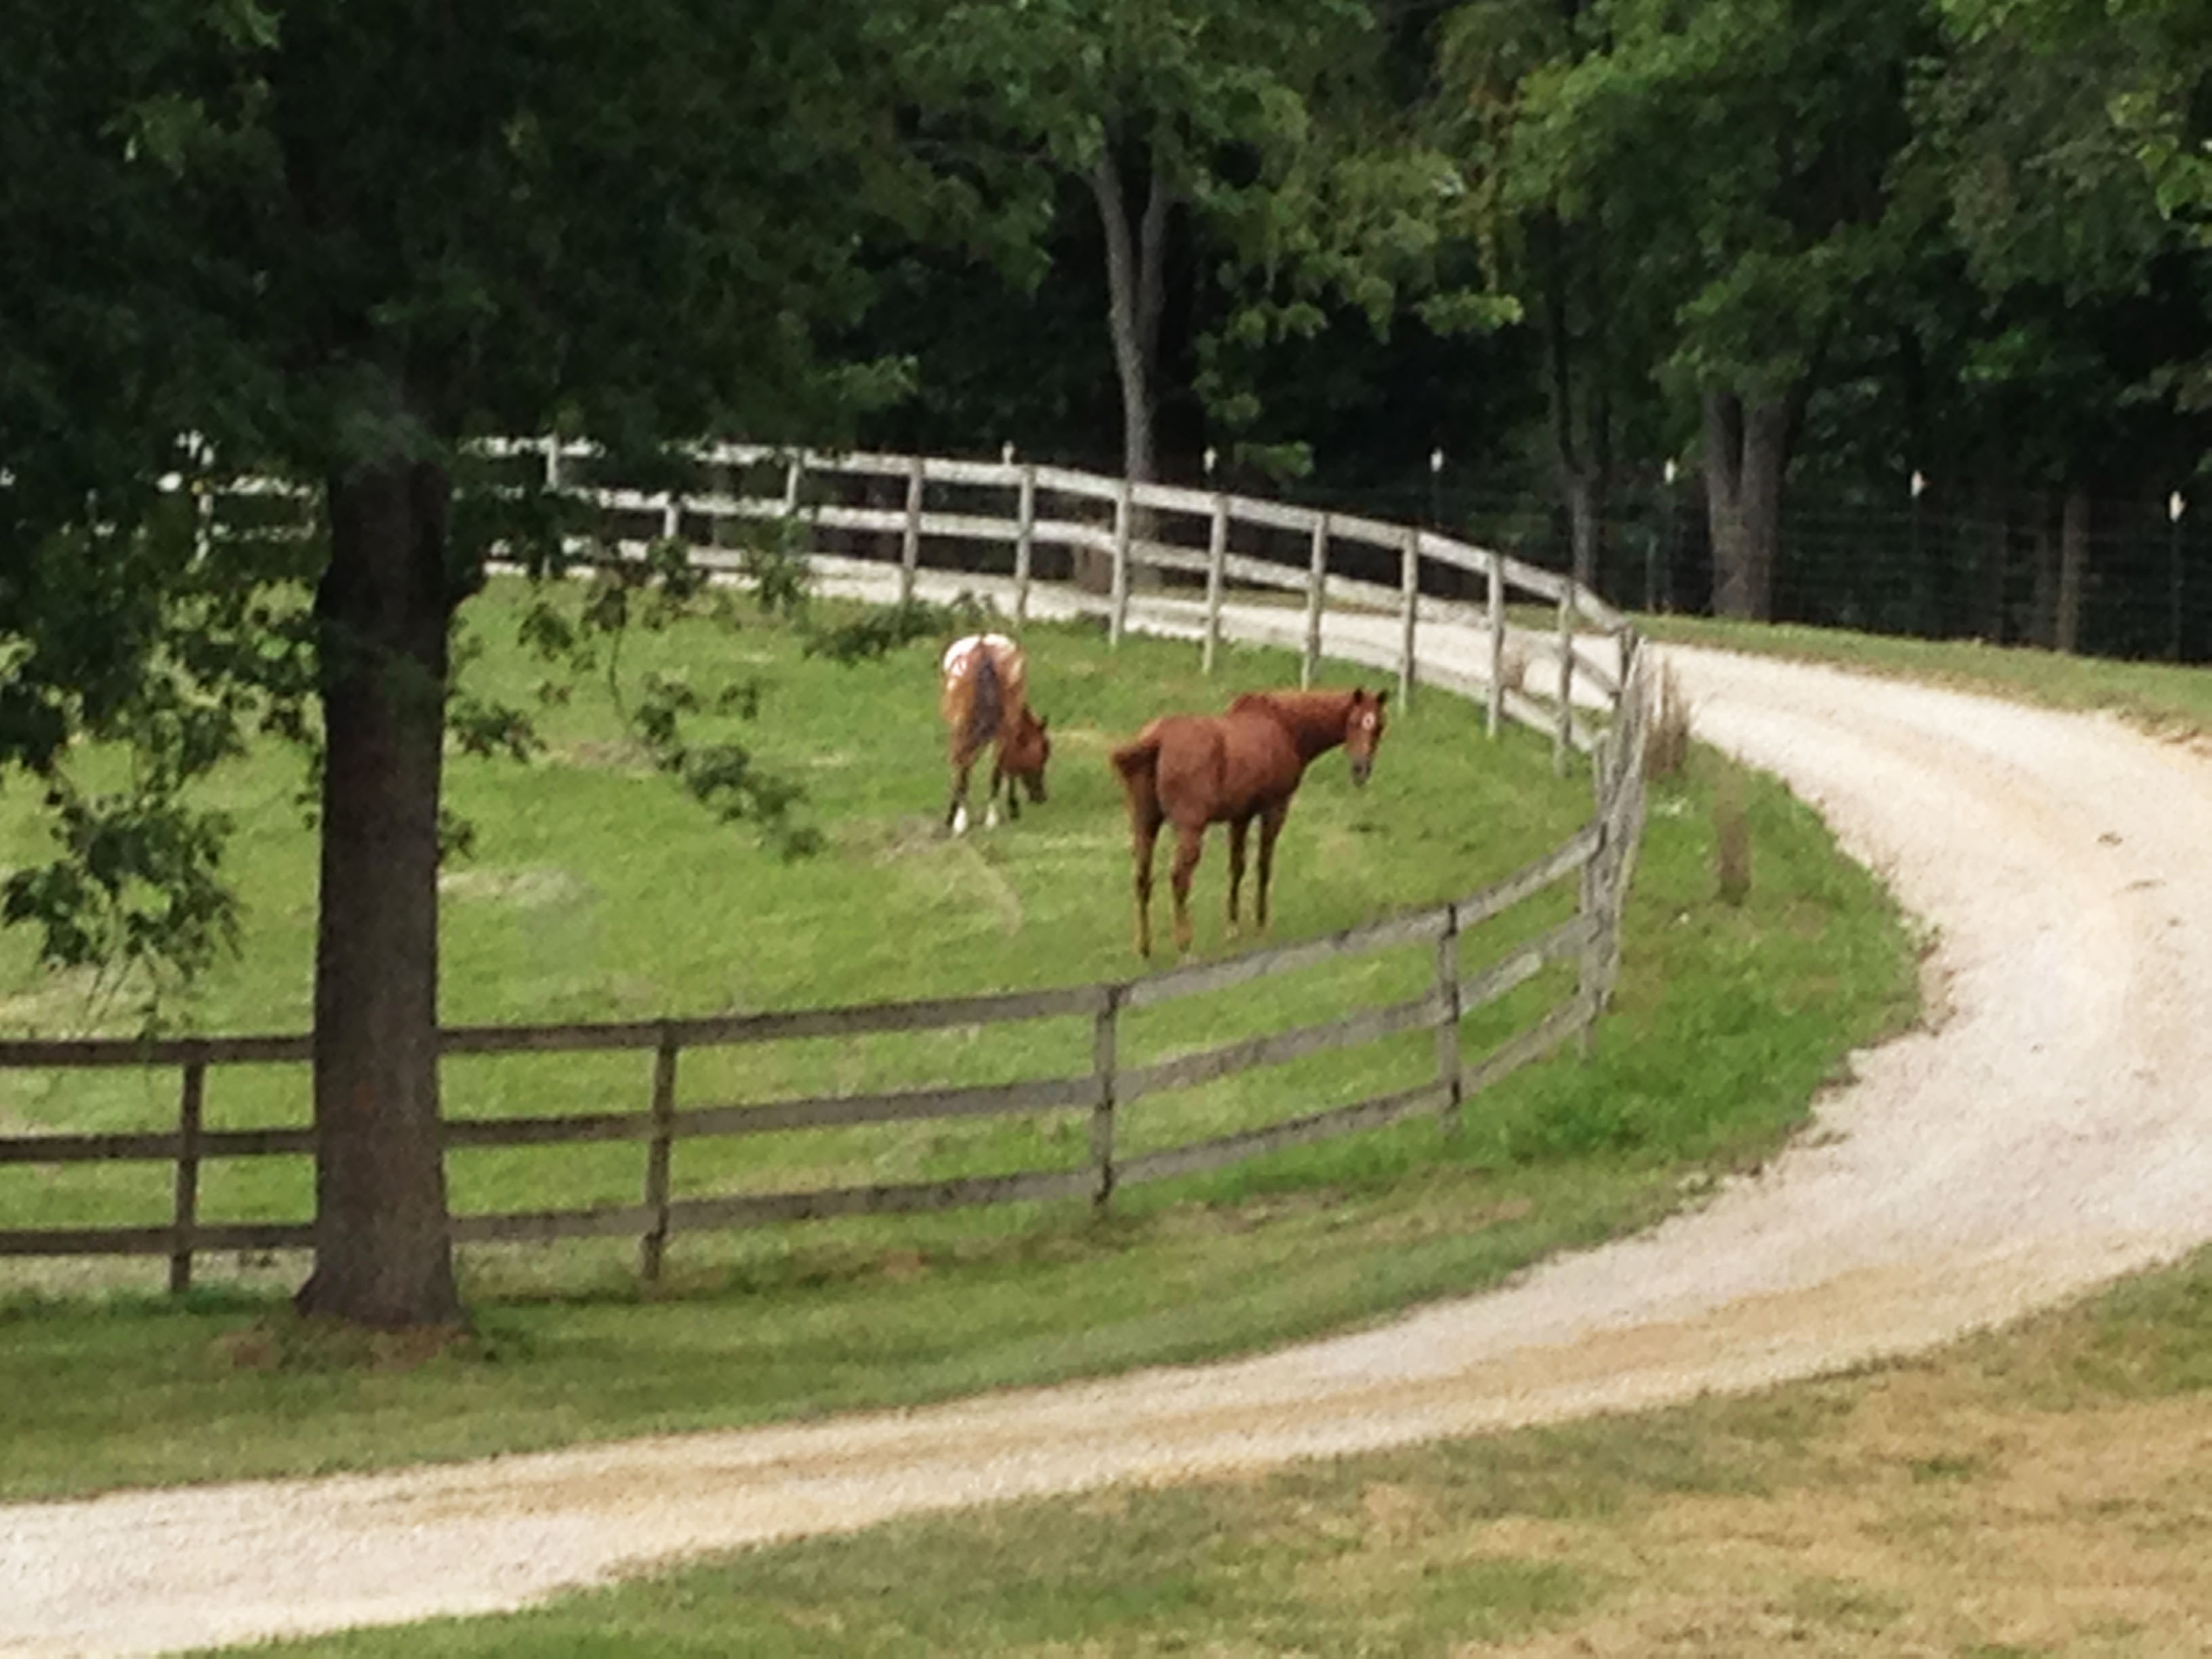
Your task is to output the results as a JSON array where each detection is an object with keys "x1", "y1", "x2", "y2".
[{"x1": 294, "y1": 458, "x2": 460, "y2": 1330}]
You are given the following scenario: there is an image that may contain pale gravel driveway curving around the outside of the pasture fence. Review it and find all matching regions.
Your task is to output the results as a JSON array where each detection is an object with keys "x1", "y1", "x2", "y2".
[{"x1": 0, "y1": 651, "x2": 2212, "y2": 1654}]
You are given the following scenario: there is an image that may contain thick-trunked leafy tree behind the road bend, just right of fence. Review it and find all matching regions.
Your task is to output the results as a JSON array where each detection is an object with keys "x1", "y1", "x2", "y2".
[{"x1": 1517, "y1": 0, "x2": 1931, "y2": 617}]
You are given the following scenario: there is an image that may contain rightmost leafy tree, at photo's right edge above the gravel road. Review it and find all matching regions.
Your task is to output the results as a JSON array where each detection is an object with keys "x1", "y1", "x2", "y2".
[{"x1": 1902, "y1": 0, "x2": 2212, "y2": 651}]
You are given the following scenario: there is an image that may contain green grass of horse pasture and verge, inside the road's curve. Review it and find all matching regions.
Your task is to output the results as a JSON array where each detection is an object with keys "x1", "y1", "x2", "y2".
[{"x1": 0, "y1": 590, "x2": 1918, "y2": 1498}]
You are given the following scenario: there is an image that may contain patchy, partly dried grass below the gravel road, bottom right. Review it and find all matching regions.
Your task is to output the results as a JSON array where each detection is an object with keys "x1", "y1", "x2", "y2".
[{"x1": 237, "y1": 1252, "x2": 2212, "y2": 1659}]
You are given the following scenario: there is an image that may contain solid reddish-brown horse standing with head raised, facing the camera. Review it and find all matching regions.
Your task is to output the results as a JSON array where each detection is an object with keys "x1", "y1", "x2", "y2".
[{"x1": 1113, "y1": 688, "x2": 1389, "y2": 956}]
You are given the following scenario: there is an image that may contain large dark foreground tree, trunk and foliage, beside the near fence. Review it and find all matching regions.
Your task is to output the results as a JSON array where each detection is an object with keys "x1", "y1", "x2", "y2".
[{"x1": 0, "y1": 0, "x2": 927, "y2": 1327}]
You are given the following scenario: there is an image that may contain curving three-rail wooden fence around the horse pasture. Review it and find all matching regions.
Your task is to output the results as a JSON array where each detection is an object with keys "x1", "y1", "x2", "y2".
[{"x1": 0, "y1": 441, "x2": 1652, "y2": 1292}]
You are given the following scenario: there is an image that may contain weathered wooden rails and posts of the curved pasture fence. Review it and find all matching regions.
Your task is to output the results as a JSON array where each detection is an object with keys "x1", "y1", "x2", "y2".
[{"x1": 0, "y1": 445, "x2": 1650, "y2": 1290}]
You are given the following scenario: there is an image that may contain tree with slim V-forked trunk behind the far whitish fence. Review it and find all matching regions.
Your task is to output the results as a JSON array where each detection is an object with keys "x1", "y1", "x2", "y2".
[{"x1": 903, "y1": 0, "x2": 1435, "y2": 510}]
